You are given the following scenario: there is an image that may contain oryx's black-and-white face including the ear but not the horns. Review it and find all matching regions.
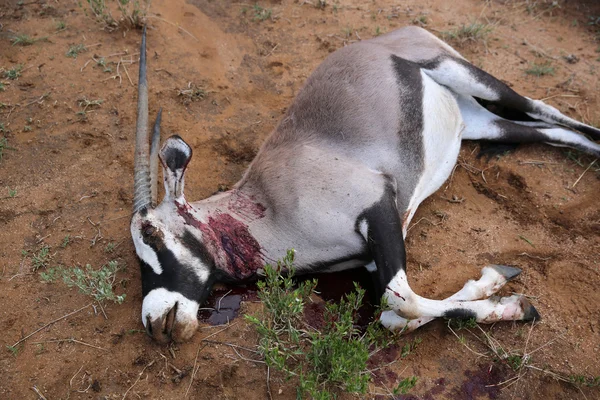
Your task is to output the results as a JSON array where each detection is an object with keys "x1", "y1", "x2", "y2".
[{"x1": 131, "y1": 136, "x2": 214, "y2": 342}]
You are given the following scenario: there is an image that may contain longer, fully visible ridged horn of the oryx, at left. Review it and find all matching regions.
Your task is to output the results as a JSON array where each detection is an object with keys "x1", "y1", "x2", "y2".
[{"x1": 133, "y1": 26, "x2": 152, "y2": 213}]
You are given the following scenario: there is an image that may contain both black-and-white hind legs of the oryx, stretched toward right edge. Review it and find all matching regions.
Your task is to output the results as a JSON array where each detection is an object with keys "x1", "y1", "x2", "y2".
[{"x1": 423, "y1": 56, "x2": 600, "y2": 156}]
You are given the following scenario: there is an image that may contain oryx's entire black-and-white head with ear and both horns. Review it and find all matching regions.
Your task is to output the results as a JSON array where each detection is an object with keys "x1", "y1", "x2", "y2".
[{"x1": 131, "y1": 28, "x2": 213, "y2": 342}]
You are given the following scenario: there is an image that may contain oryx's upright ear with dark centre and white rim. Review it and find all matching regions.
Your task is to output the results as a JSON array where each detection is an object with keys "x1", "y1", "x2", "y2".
[{"x1": 159, "y1": 135, "x2": 192, "y2": 199}]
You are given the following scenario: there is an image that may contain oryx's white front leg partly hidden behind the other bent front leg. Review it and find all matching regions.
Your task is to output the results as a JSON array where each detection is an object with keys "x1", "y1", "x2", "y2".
[{"x1": 381, "y1": 265, "x2": 521, "y2": 332}]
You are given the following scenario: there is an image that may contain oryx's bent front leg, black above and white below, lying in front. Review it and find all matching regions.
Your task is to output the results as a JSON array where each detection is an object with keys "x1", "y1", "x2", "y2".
[{"x1": 359, "y1": 185, "x2": 540, "y2": 330}]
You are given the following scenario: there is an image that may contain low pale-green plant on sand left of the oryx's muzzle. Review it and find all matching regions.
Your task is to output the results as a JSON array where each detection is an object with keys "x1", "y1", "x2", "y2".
[{"x1": 40, "y1": 260, "x2": 125, "y2": 304}]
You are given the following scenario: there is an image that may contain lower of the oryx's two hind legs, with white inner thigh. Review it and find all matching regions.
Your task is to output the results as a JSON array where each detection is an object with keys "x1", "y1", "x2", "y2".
[{"x1": 457, "y1": 95, "x2": 600, "y2": 157}]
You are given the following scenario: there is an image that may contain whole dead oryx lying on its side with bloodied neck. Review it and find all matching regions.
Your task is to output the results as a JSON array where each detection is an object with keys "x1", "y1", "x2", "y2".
[{"x1": 131, "y1": 27, "x2": 600, "y2": 341}]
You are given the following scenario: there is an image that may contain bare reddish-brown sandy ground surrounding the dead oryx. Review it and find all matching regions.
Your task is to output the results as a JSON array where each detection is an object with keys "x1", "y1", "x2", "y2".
[{"x1": 0, "y1": 0, "x2": 600, "y2": 400}]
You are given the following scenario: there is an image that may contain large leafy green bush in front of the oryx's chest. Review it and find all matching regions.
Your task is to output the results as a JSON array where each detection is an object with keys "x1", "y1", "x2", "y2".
[{"x1": 246, "y1": 251, "x2": 408, "y2": 399}]
